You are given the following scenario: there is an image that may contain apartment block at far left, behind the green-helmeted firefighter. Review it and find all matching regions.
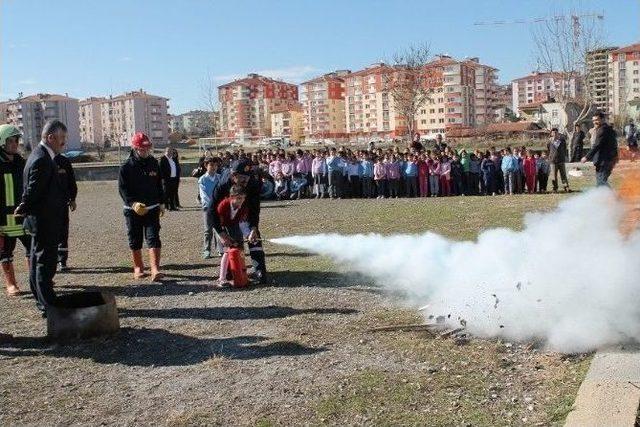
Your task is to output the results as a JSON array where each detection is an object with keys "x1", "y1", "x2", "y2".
[{"x1": 0, "y1": 93, "x2": 80, "y2": 150}]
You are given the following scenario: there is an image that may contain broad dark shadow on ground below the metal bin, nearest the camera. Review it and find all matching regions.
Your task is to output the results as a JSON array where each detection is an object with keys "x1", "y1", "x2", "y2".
[{"x1": 0, "y1": 328, "x2": 326, "y2": 366}]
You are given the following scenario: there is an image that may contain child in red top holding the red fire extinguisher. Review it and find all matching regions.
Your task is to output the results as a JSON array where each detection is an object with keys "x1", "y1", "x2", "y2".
[{"x1": 214, "y1": 186, "x2": 250, "y2": 288}]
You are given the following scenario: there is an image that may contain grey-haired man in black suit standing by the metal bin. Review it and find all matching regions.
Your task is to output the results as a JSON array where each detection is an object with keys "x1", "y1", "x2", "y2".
[{"x1": 15, "y1": 119, "x2": 68, "y2": 313}]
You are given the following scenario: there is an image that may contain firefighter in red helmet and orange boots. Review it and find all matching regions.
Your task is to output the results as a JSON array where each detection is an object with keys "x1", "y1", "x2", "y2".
[{"x1": 118, "y1": 132, "x2": 164, "y2": 282}]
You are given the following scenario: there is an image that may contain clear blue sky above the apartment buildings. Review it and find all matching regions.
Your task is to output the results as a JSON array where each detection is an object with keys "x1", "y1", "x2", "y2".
[{"x1": 0, "y1": 0, "x2": 640, "y2": 114}]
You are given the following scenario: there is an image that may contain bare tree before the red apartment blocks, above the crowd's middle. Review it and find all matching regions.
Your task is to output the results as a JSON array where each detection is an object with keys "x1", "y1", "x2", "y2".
[{"x1": 383, "y1": 44, "x2": 433, "y2": 144}]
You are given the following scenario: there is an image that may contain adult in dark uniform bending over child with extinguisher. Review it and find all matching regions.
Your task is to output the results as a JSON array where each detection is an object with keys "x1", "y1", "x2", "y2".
[{"x1": 207, "y1": 160, "x2": 267, "y2": 284}]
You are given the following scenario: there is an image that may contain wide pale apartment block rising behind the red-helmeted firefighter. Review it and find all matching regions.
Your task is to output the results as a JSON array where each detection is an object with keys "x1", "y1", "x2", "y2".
[{"x1": 80, "y1": 89, "x2": 169, "y2": 147}]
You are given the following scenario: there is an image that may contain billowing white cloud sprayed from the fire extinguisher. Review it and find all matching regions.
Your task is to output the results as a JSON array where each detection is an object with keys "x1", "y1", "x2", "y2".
[{"x1": 272, "y1": 188, "x2": 640, "y2": 352}]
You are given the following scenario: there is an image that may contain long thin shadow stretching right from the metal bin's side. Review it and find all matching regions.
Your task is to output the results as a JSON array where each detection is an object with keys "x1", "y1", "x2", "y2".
[{"x1": 118, "y1": 305, "x2": 358, "y2": 320}]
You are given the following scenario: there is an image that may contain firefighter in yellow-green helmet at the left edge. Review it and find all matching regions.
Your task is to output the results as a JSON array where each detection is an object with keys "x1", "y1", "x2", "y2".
[{"x1": 0, "y1": 125, "x2": 31, "y2": 296}]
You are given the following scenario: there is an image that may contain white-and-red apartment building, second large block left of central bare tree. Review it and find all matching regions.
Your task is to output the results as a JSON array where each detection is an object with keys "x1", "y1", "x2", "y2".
[{"x1": 300, "y1": 70, "x2": 351, "y2": 139}]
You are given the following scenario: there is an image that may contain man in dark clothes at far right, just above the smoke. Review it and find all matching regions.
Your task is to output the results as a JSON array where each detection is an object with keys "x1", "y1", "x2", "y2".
[{"x1": 581, "y1": 111, "x2": 618, "y2": 187}]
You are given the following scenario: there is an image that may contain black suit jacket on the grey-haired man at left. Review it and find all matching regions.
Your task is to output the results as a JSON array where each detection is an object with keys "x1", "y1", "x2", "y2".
[{"x1": 21, "y1": 144, "x2": 68, "y2": 240}]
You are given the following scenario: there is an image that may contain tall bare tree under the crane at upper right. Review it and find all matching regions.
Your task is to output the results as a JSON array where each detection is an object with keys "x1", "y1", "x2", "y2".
[{"x1": 532, "y1": 12, "x2": 603, "y2": 135}]
